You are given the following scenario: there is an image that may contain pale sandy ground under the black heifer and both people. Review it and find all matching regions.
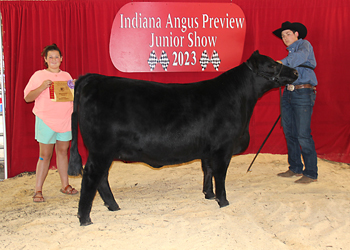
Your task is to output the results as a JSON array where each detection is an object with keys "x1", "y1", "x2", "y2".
[{"x1": 0, "y1": 154, "x2": 350, "y2": 250}]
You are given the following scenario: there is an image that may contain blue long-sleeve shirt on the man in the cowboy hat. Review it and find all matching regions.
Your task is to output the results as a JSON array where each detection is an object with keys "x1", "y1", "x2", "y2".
[{"x1": 281, "y1": 39, "x2": 317, "y2": 86}]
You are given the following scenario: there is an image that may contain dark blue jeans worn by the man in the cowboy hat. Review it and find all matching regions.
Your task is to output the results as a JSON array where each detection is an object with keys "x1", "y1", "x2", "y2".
[{"x1": 282, "y1": 88, "x2": 318, "y2": 179}]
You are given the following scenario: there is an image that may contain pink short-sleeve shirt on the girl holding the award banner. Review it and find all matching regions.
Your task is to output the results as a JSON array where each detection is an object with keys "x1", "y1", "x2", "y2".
[{"x1": 24, "y1": 69, "x2": 73, "y2": 133}]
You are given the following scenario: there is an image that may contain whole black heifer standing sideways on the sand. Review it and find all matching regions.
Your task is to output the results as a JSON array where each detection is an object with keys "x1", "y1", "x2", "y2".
[{"x1": 68, "y1": 51, "x2": 298, "y2": 225}]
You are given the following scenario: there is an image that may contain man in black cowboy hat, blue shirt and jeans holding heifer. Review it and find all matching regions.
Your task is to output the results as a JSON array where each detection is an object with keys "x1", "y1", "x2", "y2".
[{"x1": 273, "y1": 22, "x2": 318, "y2": 183}]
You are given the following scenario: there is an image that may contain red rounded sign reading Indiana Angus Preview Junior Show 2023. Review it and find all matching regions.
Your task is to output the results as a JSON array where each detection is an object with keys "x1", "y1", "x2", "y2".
[{"x1": 110, "y1": 2, "x2": 246, "y2": 72}]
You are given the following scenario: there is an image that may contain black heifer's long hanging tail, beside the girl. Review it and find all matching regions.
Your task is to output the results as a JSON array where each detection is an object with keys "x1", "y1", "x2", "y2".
[{"x1": 68, "y1": 77, "x2": 83, "y2": 176}]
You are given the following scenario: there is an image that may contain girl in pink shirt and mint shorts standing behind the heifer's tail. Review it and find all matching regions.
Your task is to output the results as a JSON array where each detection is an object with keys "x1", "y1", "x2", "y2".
[{"x1": 24, "y1": 44, "x2": 78, "y2": 202}]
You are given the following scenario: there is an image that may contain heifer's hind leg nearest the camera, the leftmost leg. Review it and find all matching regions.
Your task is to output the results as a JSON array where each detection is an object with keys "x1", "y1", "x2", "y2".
[{"x1": 78, "y1": 153, "x2": 112, "y2": 226}]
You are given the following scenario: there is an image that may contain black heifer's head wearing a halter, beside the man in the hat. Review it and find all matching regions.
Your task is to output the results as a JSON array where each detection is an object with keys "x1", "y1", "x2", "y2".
[{"x1": 245, "y1": 50, "x2": 298, "y2": 95}]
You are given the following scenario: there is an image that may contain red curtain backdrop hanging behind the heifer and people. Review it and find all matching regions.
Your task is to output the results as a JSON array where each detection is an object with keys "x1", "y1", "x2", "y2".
[{"x1": 0, "y1": 0, "x2": 350, "y2": 177}]
